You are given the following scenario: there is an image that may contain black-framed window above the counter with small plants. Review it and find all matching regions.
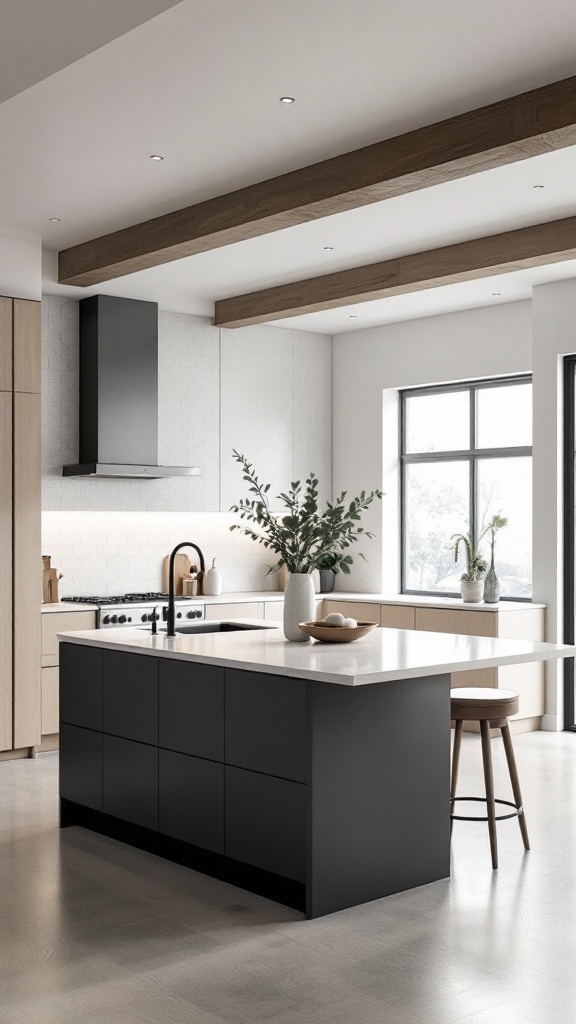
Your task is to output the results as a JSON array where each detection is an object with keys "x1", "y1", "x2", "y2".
[{"x1": 400, "y1": 377, "x2": 532, "y2": 600}]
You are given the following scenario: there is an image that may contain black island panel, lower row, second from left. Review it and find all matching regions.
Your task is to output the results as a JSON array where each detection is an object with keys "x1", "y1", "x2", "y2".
[{"x1": 102, "y1": 736, "x2": 158, "y2": 830}]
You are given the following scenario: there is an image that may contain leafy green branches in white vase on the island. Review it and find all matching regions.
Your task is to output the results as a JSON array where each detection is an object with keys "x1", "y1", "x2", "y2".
[{"x1": 230, "y1": 451, "x2": 382, "y2": 641}]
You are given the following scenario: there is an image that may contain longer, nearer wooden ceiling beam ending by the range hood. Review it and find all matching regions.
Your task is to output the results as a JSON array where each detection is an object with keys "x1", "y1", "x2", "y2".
[{"x1": 58, "y1": 77, "x2": 576, "y2": 287}]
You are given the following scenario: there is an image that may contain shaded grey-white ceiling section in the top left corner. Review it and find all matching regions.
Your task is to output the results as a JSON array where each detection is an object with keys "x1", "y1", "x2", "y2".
[{"x1": 0, "y1": 0, "x2": 179, "y2": 103}]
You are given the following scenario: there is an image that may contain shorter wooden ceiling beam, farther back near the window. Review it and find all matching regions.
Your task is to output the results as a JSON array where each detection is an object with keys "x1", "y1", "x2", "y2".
[{"x1": 215, "y1": 217, "x2": 576, "y2": 327}]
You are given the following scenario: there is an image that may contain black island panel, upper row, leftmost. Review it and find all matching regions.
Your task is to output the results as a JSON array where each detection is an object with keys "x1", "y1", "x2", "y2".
[{"x1": 59, "y1": 643, "x2": 102, "y2": 731}]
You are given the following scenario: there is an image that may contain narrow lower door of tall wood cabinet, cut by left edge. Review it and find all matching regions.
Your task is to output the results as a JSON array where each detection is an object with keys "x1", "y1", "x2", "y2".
[{"x1": 0, "y1": 387, "x2": 12, "y2": 751}]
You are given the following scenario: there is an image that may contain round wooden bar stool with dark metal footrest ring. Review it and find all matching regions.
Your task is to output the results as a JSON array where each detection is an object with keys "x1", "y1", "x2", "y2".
[{"x1": 450, "y1": 686, "x2": 530, "y2": 868}]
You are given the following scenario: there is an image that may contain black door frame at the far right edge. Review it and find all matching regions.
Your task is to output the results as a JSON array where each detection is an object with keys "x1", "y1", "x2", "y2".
[{"x1": 563, "y1": 355, "x2": 576, "y2": 732}]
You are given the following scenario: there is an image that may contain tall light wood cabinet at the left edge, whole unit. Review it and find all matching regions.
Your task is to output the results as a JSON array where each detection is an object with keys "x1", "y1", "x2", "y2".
[{"x1": 0, "y1": 297, "x2": 42, "y2": 751}]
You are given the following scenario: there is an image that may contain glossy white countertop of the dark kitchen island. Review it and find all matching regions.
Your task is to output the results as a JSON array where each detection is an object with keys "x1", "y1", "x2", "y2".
[{"x1": 58, "y1": 620, "x2": 576, "y2": 686}]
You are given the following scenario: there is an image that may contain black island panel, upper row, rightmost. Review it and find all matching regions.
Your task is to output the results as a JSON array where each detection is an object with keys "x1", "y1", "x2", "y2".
[{"x1": 224, "y1": 669, "x2": 305, "y2": 782}]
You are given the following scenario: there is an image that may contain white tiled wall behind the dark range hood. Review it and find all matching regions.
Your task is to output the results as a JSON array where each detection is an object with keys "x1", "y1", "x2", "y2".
[{"x1": 42, "y1": 295, "x2": 332, "y2": 593}]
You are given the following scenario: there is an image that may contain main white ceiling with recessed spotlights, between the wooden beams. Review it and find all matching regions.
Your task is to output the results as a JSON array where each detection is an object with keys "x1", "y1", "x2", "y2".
[{"x1": 0, "y1": 0, "x2": 576, "y2": 333}]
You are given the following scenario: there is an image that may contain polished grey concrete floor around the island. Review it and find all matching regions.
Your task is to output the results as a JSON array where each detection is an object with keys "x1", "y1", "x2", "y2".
[{"x1": 0, "y1": 733, "x2": 576, "y2": 1024}]
